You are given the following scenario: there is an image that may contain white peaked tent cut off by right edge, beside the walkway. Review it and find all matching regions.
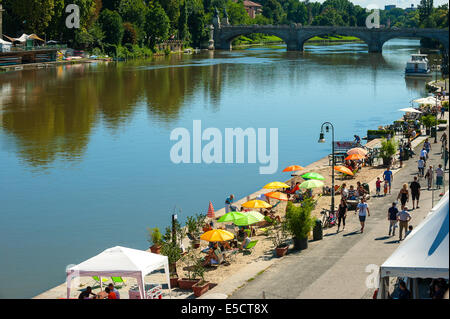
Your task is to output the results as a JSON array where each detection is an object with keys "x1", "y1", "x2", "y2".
[{"x1": 378, "y1": 191, "x2": 449, "y2": 298}]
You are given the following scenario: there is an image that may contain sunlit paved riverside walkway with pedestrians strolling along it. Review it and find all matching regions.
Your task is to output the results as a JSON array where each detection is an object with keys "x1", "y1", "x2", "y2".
[{"x1": 230, "y1": 126, "x2": 448, "y2": 299}]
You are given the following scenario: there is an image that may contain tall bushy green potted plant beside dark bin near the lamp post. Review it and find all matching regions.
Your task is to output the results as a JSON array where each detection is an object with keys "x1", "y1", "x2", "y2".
[{"x1": 286, "y1": 198, "x2": 314, "y2": 250}]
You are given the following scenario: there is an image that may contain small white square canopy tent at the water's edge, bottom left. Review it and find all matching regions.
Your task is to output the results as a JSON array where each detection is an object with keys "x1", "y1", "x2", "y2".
[{"x1": 66, "y1": 246, "x2": 171, "y2": 299}]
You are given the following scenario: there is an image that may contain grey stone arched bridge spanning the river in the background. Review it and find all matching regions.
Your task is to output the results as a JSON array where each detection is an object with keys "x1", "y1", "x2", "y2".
[{"x1": 212, "y1": 25, "x2": 449, "y2": 53}]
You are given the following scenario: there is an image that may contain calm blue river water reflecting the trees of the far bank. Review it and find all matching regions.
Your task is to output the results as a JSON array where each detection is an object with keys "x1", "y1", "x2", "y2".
[{"x1": 0, "y1": 39, "x2": 432, "y2": 298}]
